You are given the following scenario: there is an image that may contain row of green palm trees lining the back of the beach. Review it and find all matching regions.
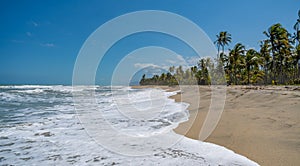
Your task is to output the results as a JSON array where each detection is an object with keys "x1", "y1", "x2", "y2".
[{"x1": 140, "y1": 10, "x2": 300, "y2": 85}]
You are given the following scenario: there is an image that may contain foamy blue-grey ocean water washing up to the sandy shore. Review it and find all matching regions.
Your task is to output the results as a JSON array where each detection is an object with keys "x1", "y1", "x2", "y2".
[{"x1": 0, "y1": 85, "x2": 257, "y2": 165}]
